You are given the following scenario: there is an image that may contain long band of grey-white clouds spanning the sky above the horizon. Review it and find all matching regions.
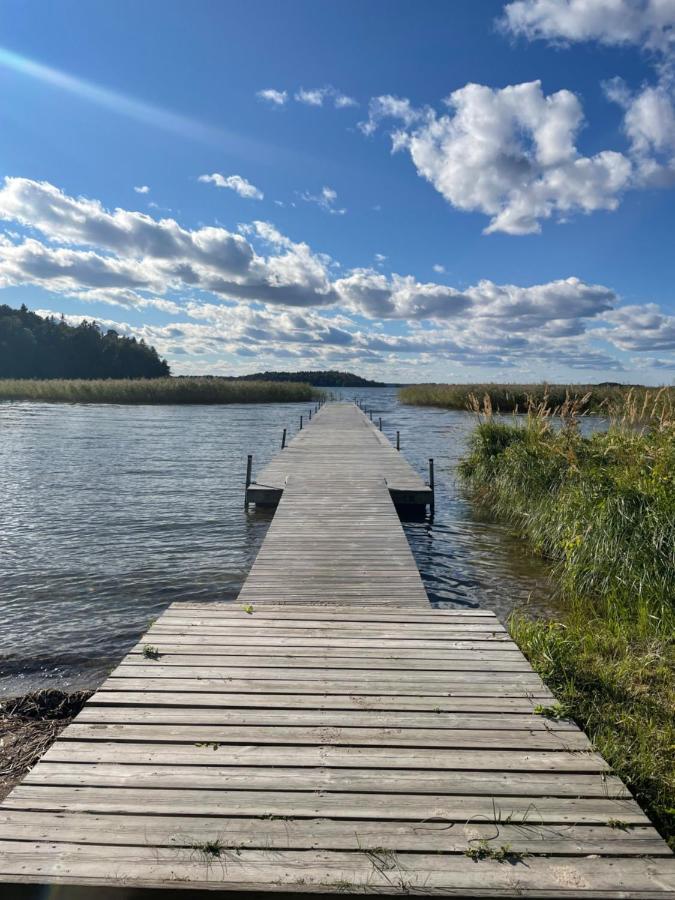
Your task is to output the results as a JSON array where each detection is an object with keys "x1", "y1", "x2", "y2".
[{"x1": 0, "y1": 179, "x2": 675, "y2": 372}]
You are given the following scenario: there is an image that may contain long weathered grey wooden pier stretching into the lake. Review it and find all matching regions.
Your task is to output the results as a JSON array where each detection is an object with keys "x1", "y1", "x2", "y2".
[{"x1": 0, "y1": 404, "x2": 675, "y2": 900}]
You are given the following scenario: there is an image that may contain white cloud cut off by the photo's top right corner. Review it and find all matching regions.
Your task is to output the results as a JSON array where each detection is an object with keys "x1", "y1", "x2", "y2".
[{"x1": 501, "y1": 0, "x2": 675, "y2": 51}]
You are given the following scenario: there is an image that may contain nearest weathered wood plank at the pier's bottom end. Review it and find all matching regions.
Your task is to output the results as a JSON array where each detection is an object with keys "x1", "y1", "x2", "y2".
[{"x1": 0, "y1": 841, "x2": 675, "y2": 900}]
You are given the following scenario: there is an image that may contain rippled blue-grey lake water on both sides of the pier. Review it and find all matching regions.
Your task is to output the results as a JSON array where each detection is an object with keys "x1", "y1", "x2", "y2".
[{"x1": 0, "y1": 388, "x2": 552, "y2": 696}]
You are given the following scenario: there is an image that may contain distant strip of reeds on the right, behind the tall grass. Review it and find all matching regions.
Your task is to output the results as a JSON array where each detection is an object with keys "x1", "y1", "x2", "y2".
[{"x1": 398, "y1": 382, "x2": 675, "y2": 415}]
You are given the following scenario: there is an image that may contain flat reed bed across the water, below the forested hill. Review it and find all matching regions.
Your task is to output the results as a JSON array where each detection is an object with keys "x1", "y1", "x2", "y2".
[{"x1": 0, "y1": 377, "x2": 322, "y2": 403}]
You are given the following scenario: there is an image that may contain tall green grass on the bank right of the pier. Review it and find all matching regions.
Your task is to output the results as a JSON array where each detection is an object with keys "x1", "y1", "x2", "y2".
[{"x1": 460, "y1": 392, "x2": 675, "y2": 848}]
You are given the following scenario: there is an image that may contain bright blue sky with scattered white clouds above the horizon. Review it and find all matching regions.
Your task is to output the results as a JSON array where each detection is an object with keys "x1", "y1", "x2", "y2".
[{"x1": 0, "y1": 0, "x2": 675, "y2": 383}]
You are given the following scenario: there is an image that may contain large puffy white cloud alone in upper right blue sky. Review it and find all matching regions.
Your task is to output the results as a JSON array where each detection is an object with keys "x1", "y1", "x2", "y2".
[{"x1": 364, "y1": 81, "x2": 632, "y2": 234}]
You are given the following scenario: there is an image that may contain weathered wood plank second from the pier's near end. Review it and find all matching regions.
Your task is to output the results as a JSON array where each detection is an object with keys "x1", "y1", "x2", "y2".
[{"x1": 0, "y1": 810, "x2": 669, "y2": 857}]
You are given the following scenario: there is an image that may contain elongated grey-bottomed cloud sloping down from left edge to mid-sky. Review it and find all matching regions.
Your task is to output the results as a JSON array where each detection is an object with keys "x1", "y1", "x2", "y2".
[{"x1": 0, "y1": 178, "x2": 337, "y2": 306}]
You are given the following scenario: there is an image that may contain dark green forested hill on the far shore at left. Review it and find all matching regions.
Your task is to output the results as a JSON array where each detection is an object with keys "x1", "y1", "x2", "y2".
[{"x1": 0, "y1": 306, "x2": 170, "y2": 378}]
